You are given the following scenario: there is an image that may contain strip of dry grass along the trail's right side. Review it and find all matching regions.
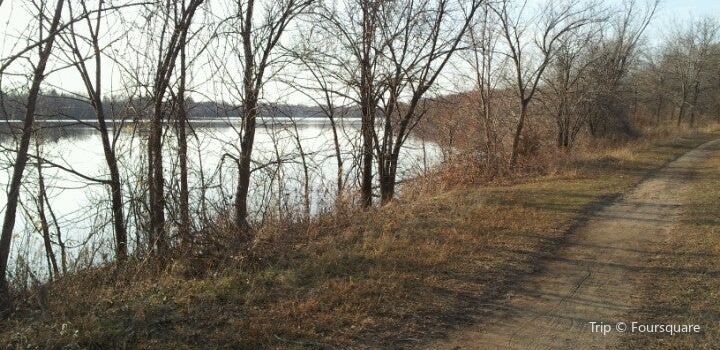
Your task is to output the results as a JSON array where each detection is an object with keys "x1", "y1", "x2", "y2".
[{"x1": 625, "y1": 136, "x2": 720, "y2": 349}]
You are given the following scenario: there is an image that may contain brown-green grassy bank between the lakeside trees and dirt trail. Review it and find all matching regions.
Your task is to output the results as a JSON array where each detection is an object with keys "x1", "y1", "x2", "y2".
[{"x1": 0, "y1": 127, "x2": 718, "y2": 349}]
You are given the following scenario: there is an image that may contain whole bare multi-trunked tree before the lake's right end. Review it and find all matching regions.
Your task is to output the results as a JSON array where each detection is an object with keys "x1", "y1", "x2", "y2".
[{"x1": 317, "y1": 0, "x2": 482, "y2": 207}]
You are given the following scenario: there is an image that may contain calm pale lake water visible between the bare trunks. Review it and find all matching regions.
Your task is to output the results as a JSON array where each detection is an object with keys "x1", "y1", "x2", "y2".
[{"x1": 0, "y1": 121, "x2": 439, "y2": 276}]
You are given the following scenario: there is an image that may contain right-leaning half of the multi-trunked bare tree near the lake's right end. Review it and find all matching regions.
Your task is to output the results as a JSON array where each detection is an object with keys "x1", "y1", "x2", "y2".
[{"x1": 373, "y1": 0, "x2": 482, "y2": 203}]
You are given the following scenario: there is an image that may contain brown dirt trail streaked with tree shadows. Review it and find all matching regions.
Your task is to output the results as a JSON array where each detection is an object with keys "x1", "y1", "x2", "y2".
[{"x1": 428, "y1": 140, "x2": 720, "y2": 349}]
